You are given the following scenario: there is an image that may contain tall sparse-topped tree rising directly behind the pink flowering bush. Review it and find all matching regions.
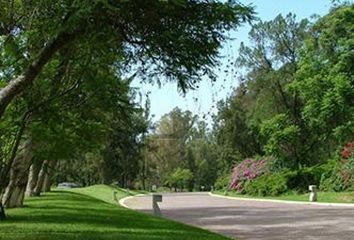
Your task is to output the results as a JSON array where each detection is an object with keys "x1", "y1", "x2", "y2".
[{"x1": 215, "y1": 14, "x2": 309, "y2": 168}]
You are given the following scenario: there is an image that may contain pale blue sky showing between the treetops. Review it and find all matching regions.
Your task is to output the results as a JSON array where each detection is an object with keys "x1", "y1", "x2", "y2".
[{"x1": 132, "y1": 0, "x2": 342, "y2": 126}]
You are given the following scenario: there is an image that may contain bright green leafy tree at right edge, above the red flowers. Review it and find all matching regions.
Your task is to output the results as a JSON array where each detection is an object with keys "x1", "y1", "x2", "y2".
[{"x1": 292, "y1": 4, "x2": 354, "y2": 152}]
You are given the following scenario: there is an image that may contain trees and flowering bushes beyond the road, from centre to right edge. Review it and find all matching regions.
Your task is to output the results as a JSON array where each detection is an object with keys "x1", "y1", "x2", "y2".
[{"x1": 135, "y1": 4, "x2": 354, "y2": 201}]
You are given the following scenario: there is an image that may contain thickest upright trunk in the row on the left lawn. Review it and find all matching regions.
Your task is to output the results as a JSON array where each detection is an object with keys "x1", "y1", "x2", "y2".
[{"x1": 2, "y1": 138, "x2": 33, "y2": 208}]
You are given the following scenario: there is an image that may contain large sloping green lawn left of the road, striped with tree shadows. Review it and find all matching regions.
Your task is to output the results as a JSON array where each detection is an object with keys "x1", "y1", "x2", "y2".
[{"x1": 0, "y1": 185, "x2": 228, "y2": 240}]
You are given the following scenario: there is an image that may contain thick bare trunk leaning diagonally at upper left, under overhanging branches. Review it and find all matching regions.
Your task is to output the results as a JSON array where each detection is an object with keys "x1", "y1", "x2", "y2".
[{"x1": 0, "y1": 33, "x2": 74, "y2": 118}]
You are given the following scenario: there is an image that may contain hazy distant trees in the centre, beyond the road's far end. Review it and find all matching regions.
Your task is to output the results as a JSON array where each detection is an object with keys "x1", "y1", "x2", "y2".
[{"x1": 141, "y1": 108, "x2": 218, "y2": 190}]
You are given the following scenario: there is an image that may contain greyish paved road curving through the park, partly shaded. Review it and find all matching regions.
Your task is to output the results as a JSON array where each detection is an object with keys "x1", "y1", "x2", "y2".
[{"x1": 125, "y1": 193, "x2": 354, "y2": 240}]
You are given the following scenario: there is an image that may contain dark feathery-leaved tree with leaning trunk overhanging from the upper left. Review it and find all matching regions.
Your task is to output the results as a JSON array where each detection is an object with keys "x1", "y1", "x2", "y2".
[{"x1": 0, "y1": 1, "x2": 253, "y2": 117}]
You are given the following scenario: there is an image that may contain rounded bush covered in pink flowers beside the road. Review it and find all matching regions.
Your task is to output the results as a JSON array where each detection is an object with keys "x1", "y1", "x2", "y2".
[{"x1": 229, "y1": 158, "x2": 270, "y2": 193}]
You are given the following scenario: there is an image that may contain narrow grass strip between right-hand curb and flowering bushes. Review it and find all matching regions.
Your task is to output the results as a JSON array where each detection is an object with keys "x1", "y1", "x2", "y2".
[{"x1": 213, "y1": 191, "x2": 354, "y2": 203}]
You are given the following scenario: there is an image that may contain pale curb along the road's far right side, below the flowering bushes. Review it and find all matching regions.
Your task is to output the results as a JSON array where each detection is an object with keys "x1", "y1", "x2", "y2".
[{"x1": 209, "y1": 192, "x2": 354, "y2": 208}]
